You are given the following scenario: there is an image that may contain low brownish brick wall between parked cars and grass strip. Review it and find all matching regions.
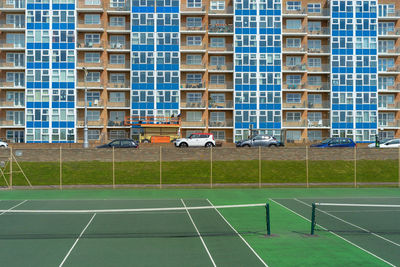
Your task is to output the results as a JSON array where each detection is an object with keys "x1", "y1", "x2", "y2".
[{"x1": 0, "y1": 147, "x2": 399, "y2": 162}]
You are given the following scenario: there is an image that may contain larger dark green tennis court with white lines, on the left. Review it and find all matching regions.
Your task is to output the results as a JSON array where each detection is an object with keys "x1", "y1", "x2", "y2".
[{"x1": 0, "y1": 199, "x2": 266, "y2": 266}]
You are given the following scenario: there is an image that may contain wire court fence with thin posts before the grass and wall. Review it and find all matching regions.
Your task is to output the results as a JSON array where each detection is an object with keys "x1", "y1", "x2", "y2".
[{"x1": 0, "y1": 146, "x2": 400, "y2": 189}]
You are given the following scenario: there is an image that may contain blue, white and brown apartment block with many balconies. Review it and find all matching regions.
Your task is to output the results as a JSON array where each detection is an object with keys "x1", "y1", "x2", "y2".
[{"x1": 0, "y1": 0, "x2": 400, "y2": 143}]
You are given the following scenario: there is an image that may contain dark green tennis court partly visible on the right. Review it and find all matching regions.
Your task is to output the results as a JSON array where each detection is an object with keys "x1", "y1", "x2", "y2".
[{"x1": 271, "y1": 197, "x2": 400, "y2": 266}]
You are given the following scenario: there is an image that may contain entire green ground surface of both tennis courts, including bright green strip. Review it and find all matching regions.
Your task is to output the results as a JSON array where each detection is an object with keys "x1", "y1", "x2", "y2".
[{"x1": 0, "y1": 188, "x2": 400, "y2": 266}]
